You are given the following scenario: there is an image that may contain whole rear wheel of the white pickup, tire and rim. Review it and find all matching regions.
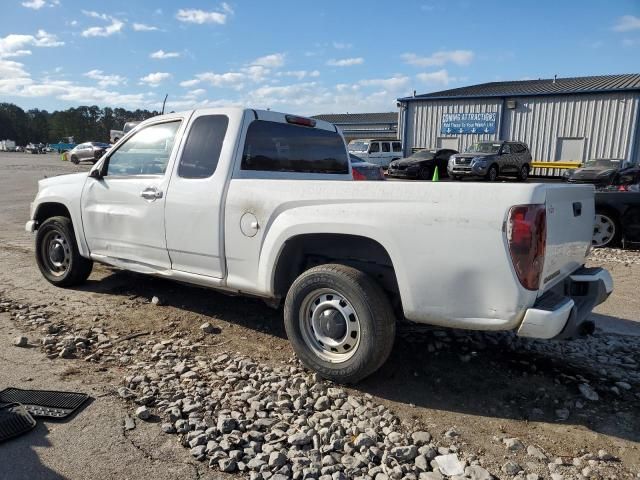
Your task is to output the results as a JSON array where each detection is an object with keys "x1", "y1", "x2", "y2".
[{"x1": 284, "y1": 264, "x2": 396, "y2": 383}]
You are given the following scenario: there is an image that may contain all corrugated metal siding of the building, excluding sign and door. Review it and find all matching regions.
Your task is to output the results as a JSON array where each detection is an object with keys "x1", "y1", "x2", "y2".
[{"x1": 398, "y1": 92, "x2": 640, "y2": 174}]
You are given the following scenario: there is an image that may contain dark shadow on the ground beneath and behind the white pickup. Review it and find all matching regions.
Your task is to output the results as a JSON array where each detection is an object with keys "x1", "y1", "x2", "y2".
[{"x1": 72, "y1": 271, "x2": 640, "y2": 442}]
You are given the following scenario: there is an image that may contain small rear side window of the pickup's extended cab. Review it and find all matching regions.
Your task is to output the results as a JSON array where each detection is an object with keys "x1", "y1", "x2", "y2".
[{"x1": 178, "y1": 115, "x2": 229, "y2": 178}]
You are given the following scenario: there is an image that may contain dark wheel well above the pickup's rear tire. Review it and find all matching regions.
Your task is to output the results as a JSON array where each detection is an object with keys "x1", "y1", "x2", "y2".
[{"x1": 274, "y1": 233, "x2": 400, "y2": 303}]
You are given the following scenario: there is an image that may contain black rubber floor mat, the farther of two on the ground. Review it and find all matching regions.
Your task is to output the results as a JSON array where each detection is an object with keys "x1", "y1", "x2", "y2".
[{"x1": 0, "y1": 388, "x2": 89, "y2": 418}]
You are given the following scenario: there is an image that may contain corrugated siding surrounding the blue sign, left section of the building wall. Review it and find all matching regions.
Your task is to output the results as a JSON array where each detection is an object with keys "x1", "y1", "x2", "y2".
[{"x1": 399, "y1": 98, "x2": 502, "y2": 151}]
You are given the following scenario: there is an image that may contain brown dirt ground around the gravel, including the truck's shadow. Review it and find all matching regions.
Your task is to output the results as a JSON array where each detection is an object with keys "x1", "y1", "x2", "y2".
[{"x1": 0, "y1": 154, "x2": 640, "y2": 480}]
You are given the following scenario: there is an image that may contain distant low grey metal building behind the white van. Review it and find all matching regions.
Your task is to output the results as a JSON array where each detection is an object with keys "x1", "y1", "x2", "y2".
[{"x1": 312, "y1": 112, "x2": 398, "y2": 142}]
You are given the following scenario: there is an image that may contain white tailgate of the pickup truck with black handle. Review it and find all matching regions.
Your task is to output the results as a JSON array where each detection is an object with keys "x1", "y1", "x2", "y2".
[{"x1": 540, "y1": 185, "x2": 595, "y2": 291}]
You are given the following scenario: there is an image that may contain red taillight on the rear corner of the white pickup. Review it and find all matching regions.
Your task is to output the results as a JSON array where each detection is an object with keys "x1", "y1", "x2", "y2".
[{"x1": 507, "y1": 205, "x2": 547, "y2": 290}]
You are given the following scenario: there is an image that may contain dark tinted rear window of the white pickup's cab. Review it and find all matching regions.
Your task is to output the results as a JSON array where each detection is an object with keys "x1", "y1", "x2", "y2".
[{"x1": 241, "y1": 120, "x2": 349, "y2": 174}]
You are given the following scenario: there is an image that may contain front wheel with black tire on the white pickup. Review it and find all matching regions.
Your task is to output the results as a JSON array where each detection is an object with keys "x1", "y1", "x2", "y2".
[{"x1": 36, "y1": 217, "x2": 93, "y2": 287}]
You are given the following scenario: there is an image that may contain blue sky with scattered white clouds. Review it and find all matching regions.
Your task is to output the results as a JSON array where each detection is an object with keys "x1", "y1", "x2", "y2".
[{"x1": 0, "y1": 0, "x2": 640, "y2": 115}]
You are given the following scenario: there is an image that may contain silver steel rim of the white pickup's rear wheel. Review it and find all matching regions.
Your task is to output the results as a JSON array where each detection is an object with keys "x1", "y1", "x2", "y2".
[{"x1": 299, "y1": 289, "x2": 361, "y2": 363}]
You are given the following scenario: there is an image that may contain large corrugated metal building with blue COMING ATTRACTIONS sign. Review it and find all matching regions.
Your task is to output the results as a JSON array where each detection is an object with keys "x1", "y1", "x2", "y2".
[{"x1": 398, "y1": 74, "x2": 640, "y2": 168}]
